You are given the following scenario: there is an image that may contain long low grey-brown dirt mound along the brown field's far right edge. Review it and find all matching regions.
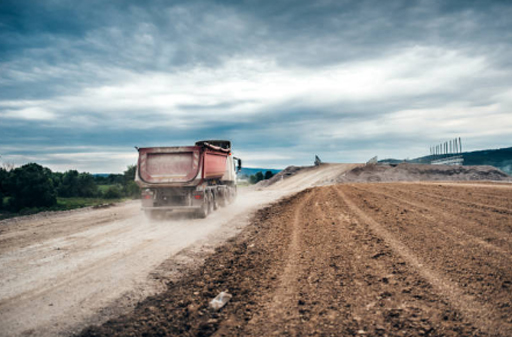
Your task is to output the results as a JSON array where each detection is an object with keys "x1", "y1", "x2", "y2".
[{"x1": 332, "y1": 163, "x2": 512, "y2": 183}]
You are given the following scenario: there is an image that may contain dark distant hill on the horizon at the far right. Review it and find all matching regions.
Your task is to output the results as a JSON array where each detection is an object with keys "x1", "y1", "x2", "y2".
[{"x1": 379, "y1": 147, "x2": 512, "y2": 175}]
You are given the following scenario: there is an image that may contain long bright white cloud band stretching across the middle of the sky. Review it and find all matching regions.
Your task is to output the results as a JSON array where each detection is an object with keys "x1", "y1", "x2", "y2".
[{"x1": 0, "y1": 47, "x2": 498, "y2": 128}]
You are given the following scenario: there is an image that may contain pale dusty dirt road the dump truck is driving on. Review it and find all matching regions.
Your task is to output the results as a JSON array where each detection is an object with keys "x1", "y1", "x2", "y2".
[{"x1": 0, "y1": 164, "x2": 360, "y2": 336}]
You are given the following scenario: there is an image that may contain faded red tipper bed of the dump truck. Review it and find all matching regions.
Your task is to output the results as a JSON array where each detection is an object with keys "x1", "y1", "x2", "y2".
[{"x1": 138, "y1": 142, "x2": 229, "y2": 184}]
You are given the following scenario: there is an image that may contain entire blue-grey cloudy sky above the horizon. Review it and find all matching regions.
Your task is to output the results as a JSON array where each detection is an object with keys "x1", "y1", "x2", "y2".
[{"x1": 0, "y1": 0, "x2": 512, "y2": 172}]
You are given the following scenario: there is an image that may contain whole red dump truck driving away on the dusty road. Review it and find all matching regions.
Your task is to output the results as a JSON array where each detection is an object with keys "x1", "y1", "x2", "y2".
[{"x1": 135, "y1": 140, "x2": 242, "y2": 218}]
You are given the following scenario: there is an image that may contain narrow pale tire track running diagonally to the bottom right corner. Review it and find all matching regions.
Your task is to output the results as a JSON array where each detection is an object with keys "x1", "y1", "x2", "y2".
[{"x1": 337, "y1": 187, "x2": 512, "y2": 336}]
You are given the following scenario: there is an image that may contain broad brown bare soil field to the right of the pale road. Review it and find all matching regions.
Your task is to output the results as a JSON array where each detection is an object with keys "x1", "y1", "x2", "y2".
[{"x1": 77, "y1": 183, "x2": 512, "y2": 336}]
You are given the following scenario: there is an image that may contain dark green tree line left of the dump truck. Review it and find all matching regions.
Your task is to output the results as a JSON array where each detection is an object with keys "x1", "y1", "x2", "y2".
[{"x1": 0, "y1": 163, "x2": 139, "y2": 212}]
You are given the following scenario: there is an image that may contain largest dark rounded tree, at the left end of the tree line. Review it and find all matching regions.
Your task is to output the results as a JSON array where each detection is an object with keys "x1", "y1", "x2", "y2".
[{"x1": 7, "y1": 163, "x2": 57, "y2": 211}]
